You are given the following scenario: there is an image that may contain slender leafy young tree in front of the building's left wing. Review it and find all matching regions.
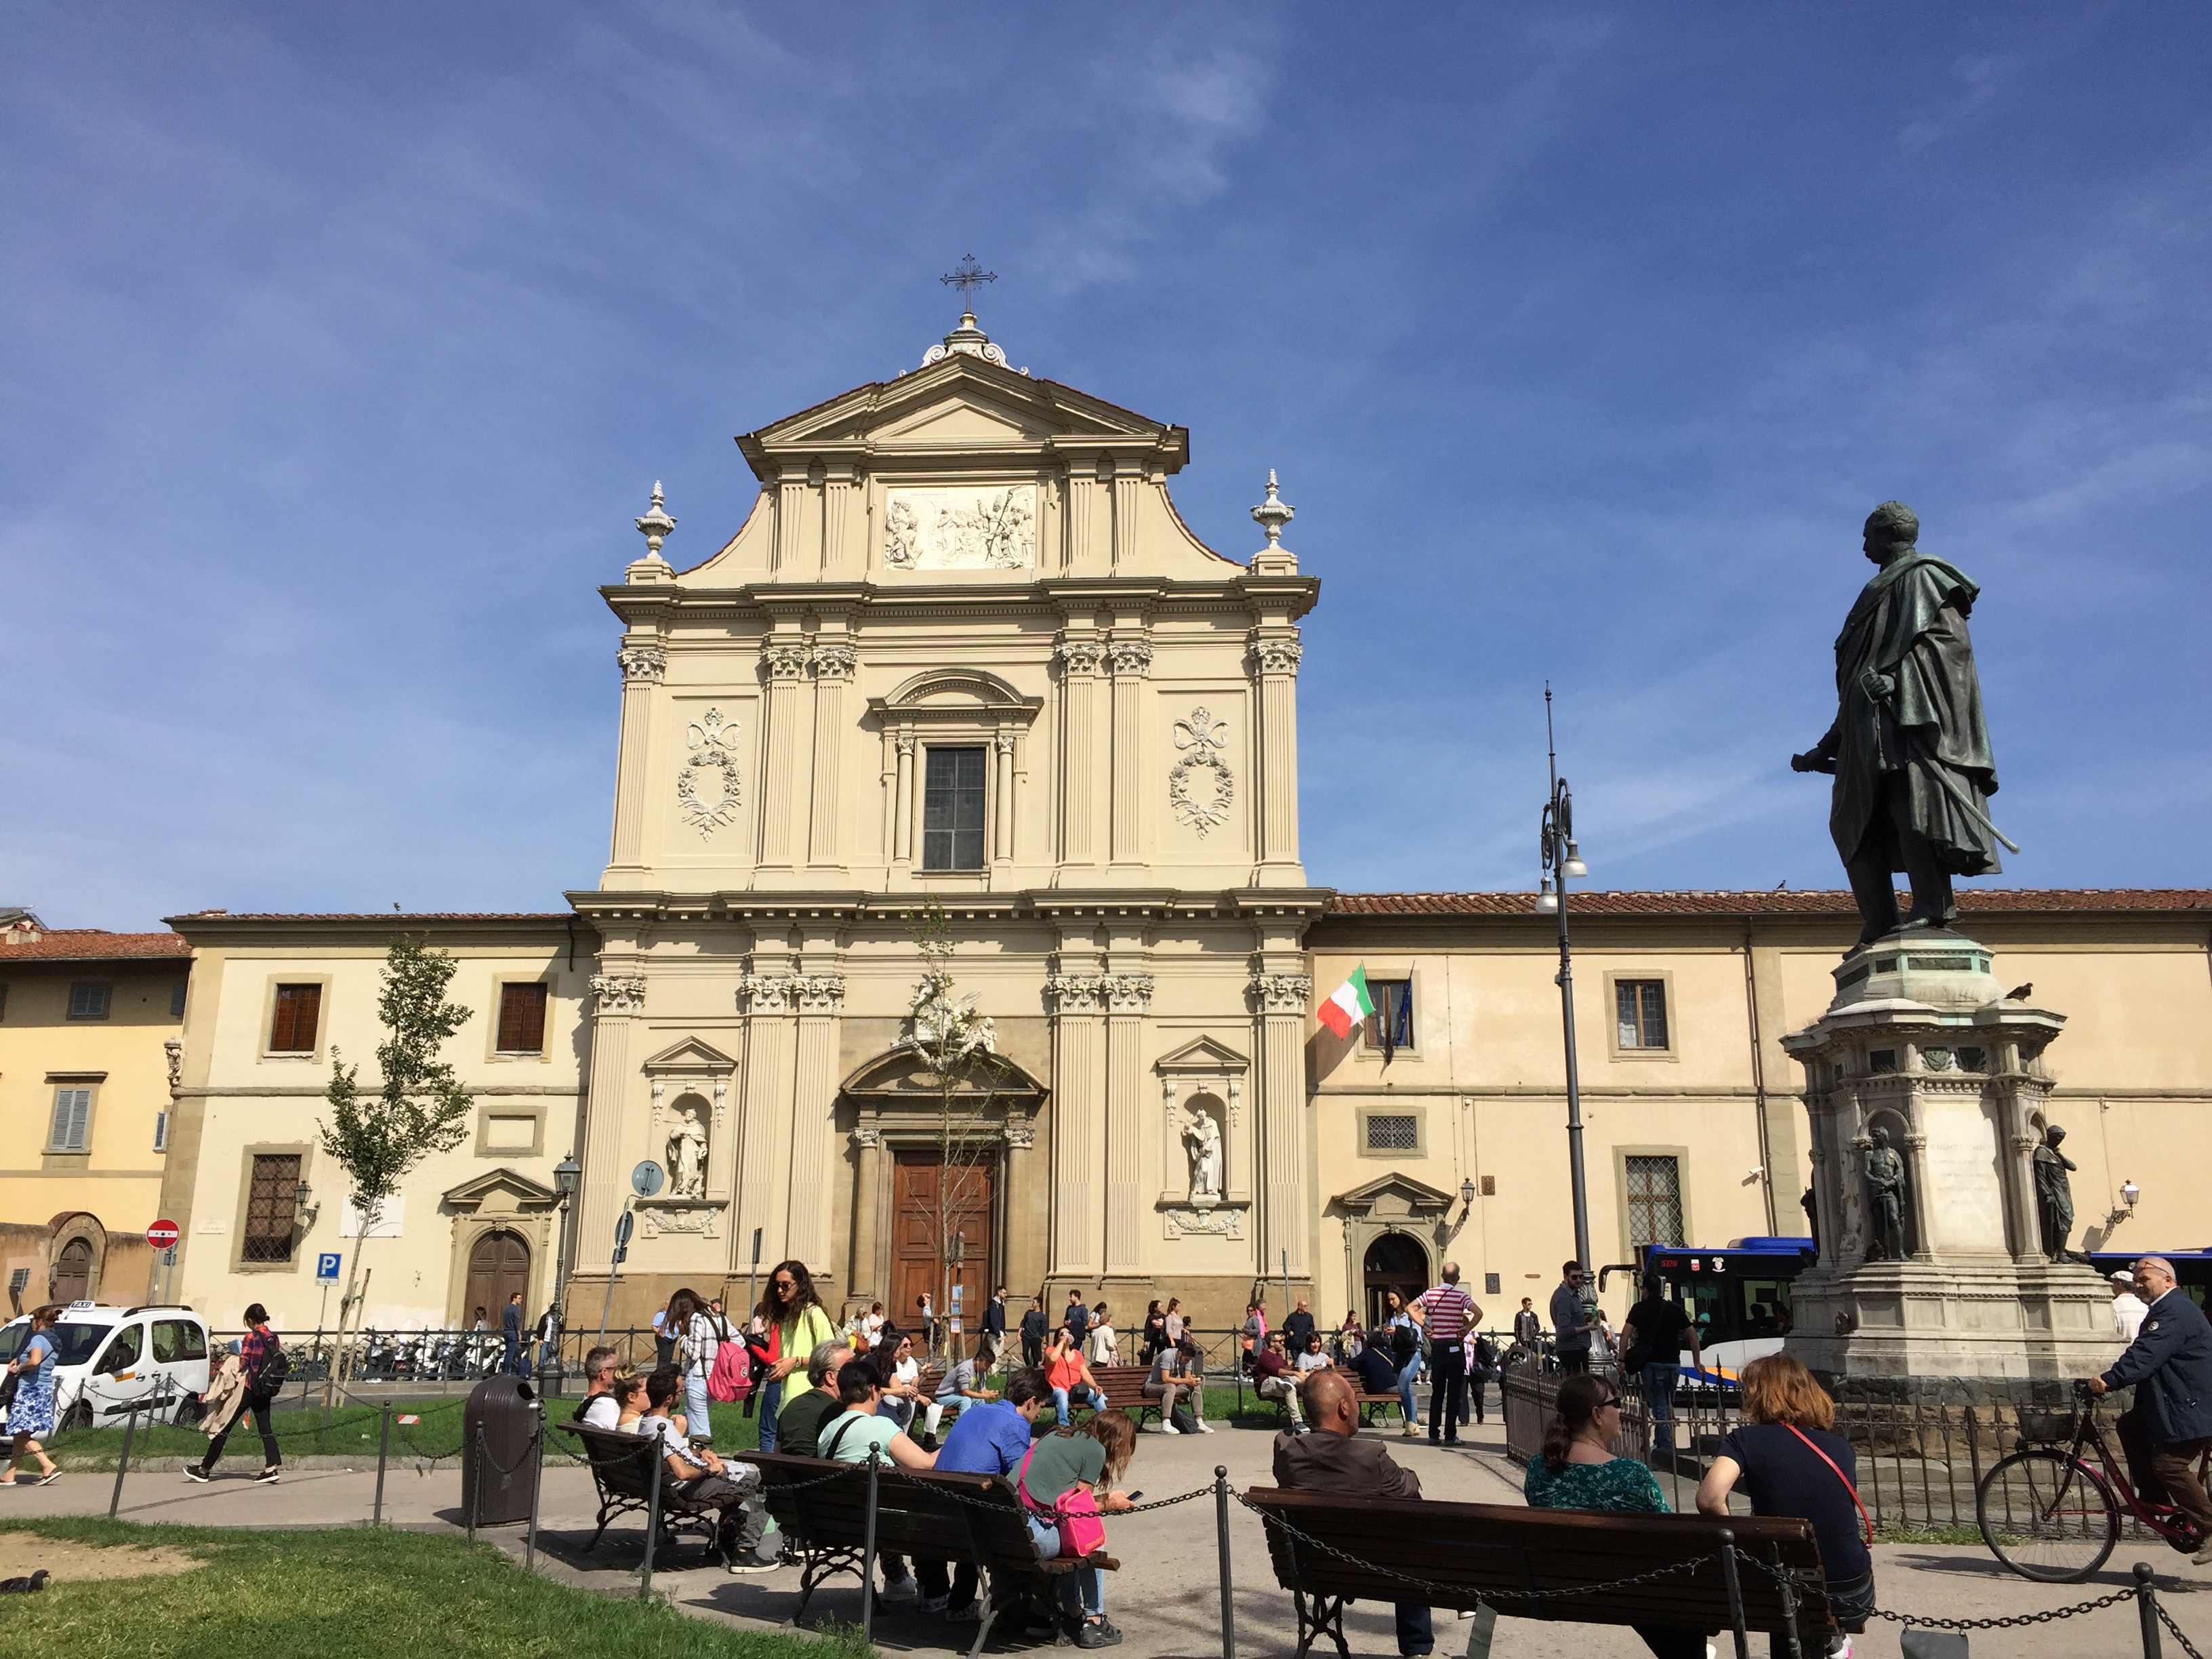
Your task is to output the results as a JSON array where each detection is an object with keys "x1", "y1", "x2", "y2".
[{"x1": 316, "y1": 936, "x2": 469, "y2": 1405}]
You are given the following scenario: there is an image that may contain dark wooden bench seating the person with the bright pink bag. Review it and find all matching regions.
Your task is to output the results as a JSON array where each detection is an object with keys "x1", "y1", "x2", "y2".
[{"x1": 745, "y1": 1451, "x2": 1122, "y2": 1659}]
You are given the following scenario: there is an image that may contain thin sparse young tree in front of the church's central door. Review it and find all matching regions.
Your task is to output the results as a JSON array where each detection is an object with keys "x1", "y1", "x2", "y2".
[{"x1": 907, "y1": 898, "x2": 1017, "y2": 1362}]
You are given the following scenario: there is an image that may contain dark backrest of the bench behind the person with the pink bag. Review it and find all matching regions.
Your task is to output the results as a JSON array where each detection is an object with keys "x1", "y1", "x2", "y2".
[{"x1": 741, "y1": 1451, "x2": 1038, "y2": 1570}]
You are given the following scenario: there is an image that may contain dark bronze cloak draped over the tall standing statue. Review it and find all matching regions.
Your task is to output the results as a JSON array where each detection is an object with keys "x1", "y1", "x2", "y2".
[{"x1": 1827, "y1": 548, "x2": 2002, "y2": 876}]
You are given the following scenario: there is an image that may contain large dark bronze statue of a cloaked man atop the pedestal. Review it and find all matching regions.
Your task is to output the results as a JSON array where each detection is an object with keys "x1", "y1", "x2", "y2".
[{"x1": 1790, "y1": 502, "x2": 2000, "y2": 945}]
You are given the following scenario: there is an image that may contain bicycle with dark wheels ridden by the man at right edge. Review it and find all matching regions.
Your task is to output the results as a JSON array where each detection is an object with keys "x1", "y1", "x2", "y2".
[{"x1": 1973, "y1": 1382, "x2": 2212, "y2": 1584}]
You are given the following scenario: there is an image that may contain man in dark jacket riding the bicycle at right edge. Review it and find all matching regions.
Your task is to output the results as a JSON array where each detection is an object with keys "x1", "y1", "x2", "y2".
[{"x1": 2088, "y1": 1256, "x2": 2212, "y2": 1566}]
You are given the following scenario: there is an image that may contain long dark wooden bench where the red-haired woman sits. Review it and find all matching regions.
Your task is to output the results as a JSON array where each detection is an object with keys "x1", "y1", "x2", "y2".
[{"x1": 1246, "y1": 1486, "x2": 1836, "y2": 1659}]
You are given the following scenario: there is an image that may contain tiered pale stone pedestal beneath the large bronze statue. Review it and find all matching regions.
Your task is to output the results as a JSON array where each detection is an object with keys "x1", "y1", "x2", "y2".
[{"x1": 1783, "y1": 929, "x2": 2121, "y2": 1398}]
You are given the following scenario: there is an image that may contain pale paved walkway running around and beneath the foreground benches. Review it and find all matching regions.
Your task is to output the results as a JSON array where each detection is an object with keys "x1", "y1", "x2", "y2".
[{"x1": 0, "y1": 1418, "x2": 2212, "y2": 1659}]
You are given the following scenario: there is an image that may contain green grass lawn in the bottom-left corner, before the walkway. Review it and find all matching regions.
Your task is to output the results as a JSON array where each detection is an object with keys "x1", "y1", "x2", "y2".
[{"x1": 0, "y1": 1519, "x2": 865, "y2": 1659}]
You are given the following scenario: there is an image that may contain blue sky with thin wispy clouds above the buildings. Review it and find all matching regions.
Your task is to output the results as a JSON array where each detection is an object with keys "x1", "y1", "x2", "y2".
[{"x1": 0, "y1": 0, "x2": 2212, "y2": 927}]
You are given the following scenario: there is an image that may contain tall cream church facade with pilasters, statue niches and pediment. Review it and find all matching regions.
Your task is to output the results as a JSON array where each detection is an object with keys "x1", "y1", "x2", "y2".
[{"x1": 569, "y1": 319, "x2": 1327, "y2": 1336}]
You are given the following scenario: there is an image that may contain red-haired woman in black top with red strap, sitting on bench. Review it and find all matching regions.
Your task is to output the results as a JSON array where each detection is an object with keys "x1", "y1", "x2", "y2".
[{"x1": 1696, "y1": 1354, "x2": 1874, "y2": 1659}]
